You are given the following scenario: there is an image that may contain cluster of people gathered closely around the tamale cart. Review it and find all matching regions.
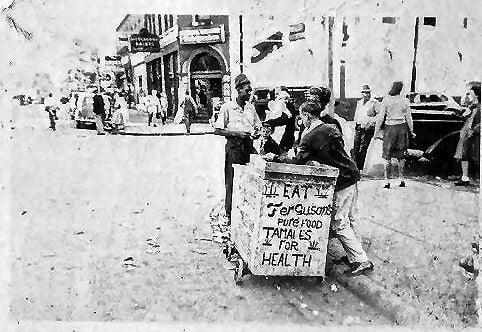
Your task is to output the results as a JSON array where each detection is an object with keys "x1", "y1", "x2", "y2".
[{"x1": 214, "y1": 74, "x2": 374, "y2": 276}]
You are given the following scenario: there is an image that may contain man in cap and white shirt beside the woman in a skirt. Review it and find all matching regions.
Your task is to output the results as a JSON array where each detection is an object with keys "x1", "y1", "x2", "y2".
[{"x1": 351, "y1": 84, "x2": 380, "y2": 170}]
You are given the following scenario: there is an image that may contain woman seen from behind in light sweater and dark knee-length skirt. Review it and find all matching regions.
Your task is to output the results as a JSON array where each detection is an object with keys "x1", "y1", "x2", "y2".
[{"x1": 374, "y1": 81, "x2": 415, "y2": 189}]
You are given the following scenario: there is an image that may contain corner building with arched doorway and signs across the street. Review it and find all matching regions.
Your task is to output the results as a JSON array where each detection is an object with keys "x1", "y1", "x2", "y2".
[{"x1": 116, "y1": 14, "x2": 231, "y2": 120}]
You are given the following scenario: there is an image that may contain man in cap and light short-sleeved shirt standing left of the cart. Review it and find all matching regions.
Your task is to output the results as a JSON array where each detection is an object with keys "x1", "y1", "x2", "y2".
[{"x1": 214, "y1": 74, "x2": 261, "y2": 225}]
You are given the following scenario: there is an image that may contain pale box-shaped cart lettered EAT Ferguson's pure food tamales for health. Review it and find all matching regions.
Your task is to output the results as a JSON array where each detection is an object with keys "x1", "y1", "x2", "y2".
[{"x1": 231, "y1": 155, "x2": 339, "y2": 283}]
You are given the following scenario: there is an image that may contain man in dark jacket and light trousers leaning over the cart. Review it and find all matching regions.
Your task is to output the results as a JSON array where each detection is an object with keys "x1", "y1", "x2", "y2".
[{"x1": 274, "y1": 101, "x2": 373, "y2": 276}]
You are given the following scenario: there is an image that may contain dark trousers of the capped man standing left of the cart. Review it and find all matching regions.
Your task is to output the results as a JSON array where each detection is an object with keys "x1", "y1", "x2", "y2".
[{"x1": 224, "y1": 137, "x2": 253, "y2": 224}]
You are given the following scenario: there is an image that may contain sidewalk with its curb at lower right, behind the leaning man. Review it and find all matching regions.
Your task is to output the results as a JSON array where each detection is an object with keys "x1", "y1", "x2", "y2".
[{"x1": 330, "y1": 180, "x2": 478, "y2": 328}]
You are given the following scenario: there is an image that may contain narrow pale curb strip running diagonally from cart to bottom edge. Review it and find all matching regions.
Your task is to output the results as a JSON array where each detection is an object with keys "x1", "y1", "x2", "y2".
[{"x1": 326, "y1": 253, "x2": 430, "y2": 325}]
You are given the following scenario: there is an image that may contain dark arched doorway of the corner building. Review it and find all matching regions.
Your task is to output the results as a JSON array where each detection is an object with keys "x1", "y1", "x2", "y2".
[{"x1": 190, "y1": 52, "x2": 223, "y2": 120}]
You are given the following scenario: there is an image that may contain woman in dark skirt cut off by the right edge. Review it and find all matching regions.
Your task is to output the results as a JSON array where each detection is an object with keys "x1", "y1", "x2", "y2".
[{"x1": 454, "y1": 81, "x2": 480, "y2": 186}]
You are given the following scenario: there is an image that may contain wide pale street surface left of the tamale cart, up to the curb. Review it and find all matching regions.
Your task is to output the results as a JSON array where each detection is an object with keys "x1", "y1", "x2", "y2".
[{"x1": 7, "y1": 107, "x2": 390, "y2": 326}]
